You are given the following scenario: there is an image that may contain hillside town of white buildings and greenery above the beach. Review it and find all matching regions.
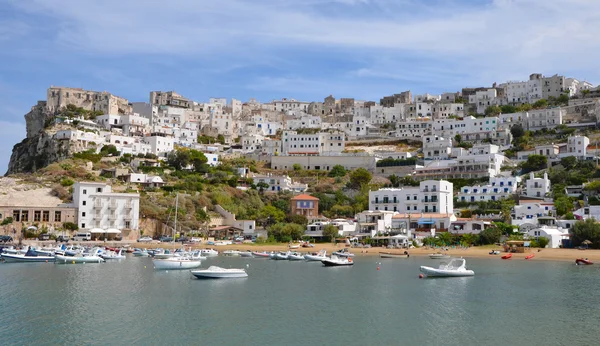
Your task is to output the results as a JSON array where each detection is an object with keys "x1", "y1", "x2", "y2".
[{"x1": 0, "y1": 74, "x2": 600, "y2": 247}]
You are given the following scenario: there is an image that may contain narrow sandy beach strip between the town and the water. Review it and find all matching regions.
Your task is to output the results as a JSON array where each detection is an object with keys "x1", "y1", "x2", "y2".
[{"x1": 23, "y1": 241, "x2": 600, "y2": 262}]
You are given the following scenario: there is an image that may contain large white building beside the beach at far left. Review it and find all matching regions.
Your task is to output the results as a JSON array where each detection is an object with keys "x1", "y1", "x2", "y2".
[{"x1": 73, "y1": 182, "x2": 140, "y2": 230}]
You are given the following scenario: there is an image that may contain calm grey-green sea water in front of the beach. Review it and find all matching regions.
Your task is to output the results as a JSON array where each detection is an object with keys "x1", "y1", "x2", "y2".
[{"x1": 0, "y1": 257, "x2": 600, "y2": 345}]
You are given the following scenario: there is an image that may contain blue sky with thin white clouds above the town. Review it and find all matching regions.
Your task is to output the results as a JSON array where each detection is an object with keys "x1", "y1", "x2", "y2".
[{"x1": 0, "y1": 0, "x2": 600, "y2": 172}]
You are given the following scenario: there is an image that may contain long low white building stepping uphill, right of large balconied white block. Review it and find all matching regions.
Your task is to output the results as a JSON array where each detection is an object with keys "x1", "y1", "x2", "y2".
[{"x1": 458, "y1": 177, "x2": 521, "y2": 202}]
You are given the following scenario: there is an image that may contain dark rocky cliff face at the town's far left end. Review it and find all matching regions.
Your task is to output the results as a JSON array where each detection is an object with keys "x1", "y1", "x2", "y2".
[{"x1": 6, "y1": 101, "x2": 77, "y2": 175}]
